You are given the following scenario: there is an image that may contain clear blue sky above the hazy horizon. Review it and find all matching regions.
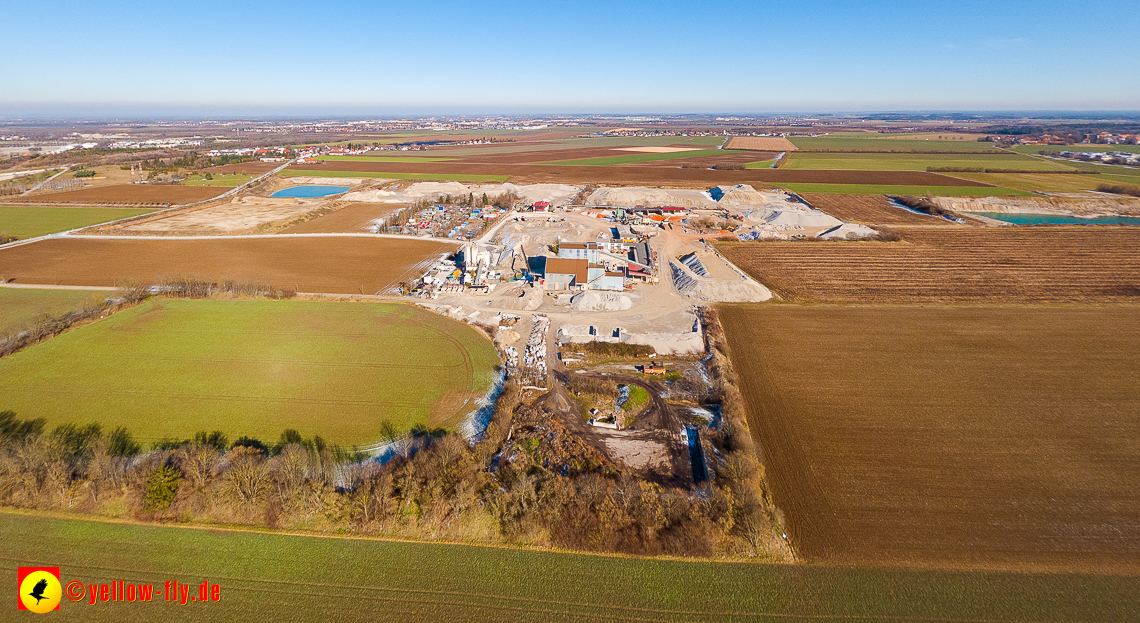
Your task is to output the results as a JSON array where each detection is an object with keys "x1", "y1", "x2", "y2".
[{"x1": 0, "y1": 0, "x2": 1140, "y2": 114}]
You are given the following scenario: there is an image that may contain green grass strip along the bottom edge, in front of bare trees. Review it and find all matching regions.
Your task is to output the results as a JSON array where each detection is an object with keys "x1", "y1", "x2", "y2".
[{"x1": 0, "y1": 512, "x2": 1140, "y2": 623}]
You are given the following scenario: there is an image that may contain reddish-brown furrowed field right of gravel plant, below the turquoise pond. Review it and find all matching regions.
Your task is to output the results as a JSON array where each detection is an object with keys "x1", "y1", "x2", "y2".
[{"x1": 717, "y1": 226, "x2": 1140, "y2": 302}]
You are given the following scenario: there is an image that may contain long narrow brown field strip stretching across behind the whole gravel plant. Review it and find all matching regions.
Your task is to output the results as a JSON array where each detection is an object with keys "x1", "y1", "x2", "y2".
[{"x1": 294, "y1": 160, "x2": 987, "y2": 186}]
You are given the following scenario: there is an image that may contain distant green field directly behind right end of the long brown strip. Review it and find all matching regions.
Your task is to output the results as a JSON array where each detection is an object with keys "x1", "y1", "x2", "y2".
[{"x1": 780, "y1": 152, "x2": 1073, "y2": 171}]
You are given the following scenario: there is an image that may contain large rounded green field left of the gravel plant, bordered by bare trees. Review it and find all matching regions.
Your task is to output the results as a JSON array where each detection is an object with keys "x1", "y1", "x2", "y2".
[{"x1": 0, "y1": 299, "x2": 499, "y2": 445}]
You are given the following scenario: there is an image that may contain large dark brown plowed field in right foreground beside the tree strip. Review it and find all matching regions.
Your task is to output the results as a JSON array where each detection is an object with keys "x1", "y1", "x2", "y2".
[{"x1": 719, "y1": 305, "x2": 1140, "y2": 573}]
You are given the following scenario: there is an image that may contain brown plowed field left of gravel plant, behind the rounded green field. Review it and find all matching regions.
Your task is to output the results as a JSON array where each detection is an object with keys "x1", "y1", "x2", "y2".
[{"x1": 0, "y1": 236, "x2": 455, "y2": 294}]
